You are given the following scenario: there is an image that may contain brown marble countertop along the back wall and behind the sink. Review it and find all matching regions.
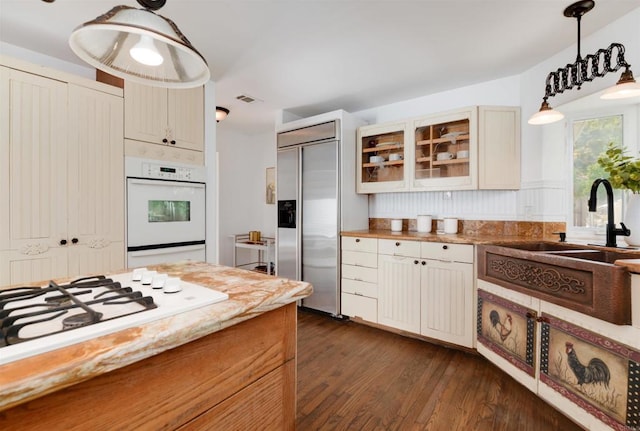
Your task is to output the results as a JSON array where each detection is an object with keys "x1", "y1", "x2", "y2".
[{"x1": 340, "y1": 229, "x2": 640, "y2": 274}]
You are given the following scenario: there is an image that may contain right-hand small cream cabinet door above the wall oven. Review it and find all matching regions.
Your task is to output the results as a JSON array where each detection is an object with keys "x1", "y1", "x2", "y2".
[{"x1": 167, "y1": 87, "x2": 204, "y2": 151}]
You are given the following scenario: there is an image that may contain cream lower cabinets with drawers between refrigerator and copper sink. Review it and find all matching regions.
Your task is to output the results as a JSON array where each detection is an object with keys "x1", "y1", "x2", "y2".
[{"x1": 342, "y1": 237, "x2": 475, "y2": 347}]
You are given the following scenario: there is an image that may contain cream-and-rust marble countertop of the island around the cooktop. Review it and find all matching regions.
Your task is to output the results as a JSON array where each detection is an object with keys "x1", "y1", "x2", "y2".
[{"x1": 0, "y1": 262, "x2": 313, "y2": 411}]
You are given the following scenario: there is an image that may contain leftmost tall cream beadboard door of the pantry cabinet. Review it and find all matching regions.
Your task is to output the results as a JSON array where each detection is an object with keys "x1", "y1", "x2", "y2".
[{"x1": 0, "y1": 68, "x2": 67, "y2": 256}]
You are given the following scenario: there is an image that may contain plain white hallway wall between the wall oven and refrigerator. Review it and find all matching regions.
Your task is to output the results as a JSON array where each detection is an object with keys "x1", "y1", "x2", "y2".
[{"x1": 217, "y1": 123, "x2": 276, "y2": 266}]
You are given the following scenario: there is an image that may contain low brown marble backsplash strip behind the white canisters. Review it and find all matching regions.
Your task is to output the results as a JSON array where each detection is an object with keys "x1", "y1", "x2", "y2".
[{"x1": 369, "y1": 218, "x2": 566, "y2": 240}]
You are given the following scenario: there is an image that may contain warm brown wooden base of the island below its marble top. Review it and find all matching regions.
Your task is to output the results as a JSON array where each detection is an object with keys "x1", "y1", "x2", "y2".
[{"x1": 0, "y1": 303, "x2": 297, "y2": 431}]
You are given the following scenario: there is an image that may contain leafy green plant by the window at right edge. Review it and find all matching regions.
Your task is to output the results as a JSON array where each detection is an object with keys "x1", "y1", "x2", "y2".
[{"x1": 598, "y1": 142, "x2": 640, "y2": 193}]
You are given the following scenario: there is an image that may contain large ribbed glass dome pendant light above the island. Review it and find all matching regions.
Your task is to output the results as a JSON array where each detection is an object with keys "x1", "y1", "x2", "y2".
[{"x1": 69, "y1": 0, "x2": 211, "y2": 88}]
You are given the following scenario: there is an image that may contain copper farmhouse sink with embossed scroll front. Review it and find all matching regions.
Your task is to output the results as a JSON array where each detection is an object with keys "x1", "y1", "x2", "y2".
[{"x1": 478, "y1": 241, "x2": 640, "y2": 325}]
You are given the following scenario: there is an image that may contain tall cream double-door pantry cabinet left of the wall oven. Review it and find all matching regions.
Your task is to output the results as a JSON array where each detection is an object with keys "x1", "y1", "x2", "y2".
[{"x1": 0, "y1": 63, "x2": 124, "y2": 286}]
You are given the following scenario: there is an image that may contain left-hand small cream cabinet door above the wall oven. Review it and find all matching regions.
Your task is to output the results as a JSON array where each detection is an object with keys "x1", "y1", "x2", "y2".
[{"x1": 124, "y1": 81, "x2": 169, "y2": 144}]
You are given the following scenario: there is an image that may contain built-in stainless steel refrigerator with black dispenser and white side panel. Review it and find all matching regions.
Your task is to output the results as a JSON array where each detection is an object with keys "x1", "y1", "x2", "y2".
[{"x1": 276, "y1": 111, "x2": 369, "y2": 317}]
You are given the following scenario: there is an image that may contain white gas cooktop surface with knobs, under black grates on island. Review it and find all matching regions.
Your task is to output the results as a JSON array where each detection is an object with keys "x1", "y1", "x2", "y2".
[{"x1": 0, "y1": 273, "x2": 229, "y2": 365}]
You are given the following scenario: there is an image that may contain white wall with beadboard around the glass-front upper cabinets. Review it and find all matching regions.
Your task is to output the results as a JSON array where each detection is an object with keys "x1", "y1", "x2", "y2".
[{"x1": 355, "y1": 8, "x2": 640, "y2": 221}]
